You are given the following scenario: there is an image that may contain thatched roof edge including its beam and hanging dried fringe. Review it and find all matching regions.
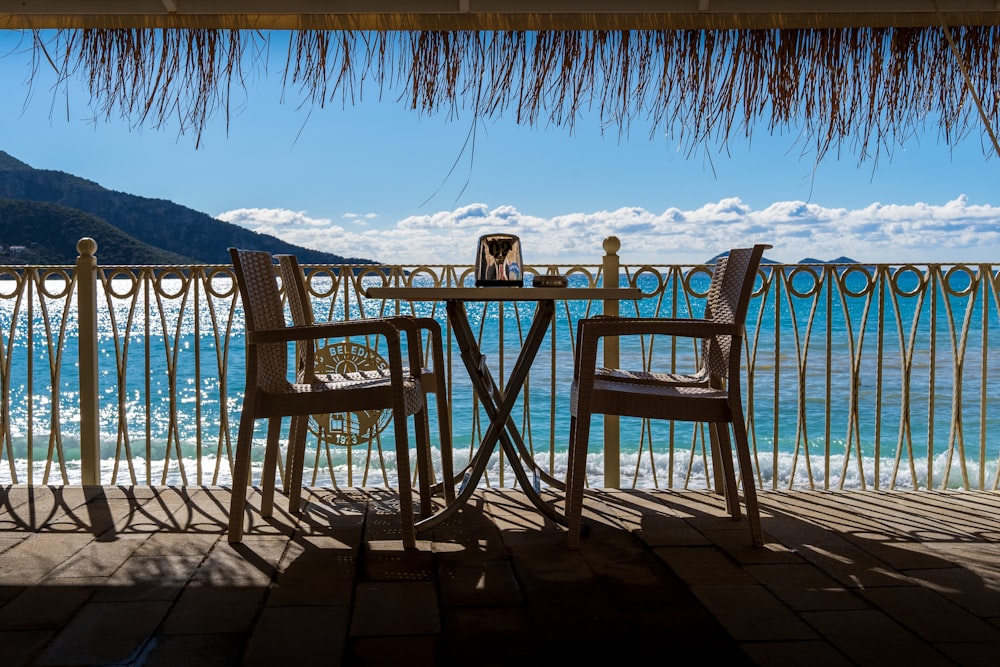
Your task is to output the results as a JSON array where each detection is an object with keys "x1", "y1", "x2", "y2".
[{"x1": 0, "y1": 5, "x2": 1000, "y2": 160}]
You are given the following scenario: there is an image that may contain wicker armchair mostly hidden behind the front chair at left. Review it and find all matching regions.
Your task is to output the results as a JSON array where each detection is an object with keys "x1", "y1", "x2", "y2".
[{"x1": 275, "y1": 255, "x2": 455, "y2": 517}]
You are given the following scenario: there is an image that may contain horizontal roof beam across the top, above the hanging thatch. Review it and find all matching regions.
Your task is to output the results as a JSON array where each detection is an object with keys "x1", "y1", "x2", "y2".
[{"x1": 0, "y1": 0, "x2": 1000, "y2": 30}]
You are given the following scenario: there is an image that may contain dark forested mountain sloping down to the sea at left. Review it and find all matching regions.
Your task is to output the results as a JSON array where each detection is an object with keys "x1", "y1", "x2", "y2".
[{"x1": 0, "y1": 151, "x2": 374, "y2": 264}]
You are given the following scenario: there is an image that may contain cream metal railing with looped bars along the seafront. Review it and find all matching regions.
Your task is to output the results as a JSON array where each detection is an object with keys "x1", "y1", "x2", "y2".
[{"x1": 0, "y1": 241, "x2": 1000, "y2": 490}]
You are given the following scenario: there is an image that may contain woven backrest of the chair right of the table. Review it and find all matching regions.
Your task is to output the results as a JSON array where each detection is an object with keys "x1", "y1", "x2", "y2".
[{"x1": 702, "y1": 245, "x2": 771, "y2": 379}]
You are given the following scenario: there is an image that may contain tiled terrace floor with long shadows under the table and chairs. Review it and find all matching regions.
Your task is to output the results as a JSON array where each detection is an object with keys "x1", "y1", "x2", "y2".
[{"x1": 0, "y1": 486, "x2": 1000, "y2": 667}]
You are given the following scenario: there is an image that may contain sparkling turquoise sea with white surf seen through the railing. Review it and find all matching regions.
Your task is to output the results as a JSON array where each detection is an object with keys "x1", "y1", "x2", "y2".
[{"x1": 0, "y1": 271, "x2": 1000, "y2": 488}]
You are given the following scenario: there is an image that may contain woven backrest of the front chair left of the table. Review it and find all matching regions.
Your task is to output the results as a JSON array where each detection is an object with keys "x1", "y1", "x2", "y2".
[{"x1": 229, "y1": 248, "x2": 290, "y2": 392}]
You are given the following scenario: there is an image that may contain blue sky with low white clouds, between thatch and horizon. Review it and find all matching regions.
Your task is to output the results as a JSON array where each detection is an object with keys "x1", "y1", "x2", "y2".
[{"x1": 0, "y1": 31, "x2": 1000, "y2": 264}]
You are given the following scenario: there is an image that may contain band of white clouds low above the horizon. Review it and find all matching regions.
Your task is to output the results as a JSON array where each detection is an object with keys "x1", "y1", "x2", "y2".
[{"x1": 217, "y1": 196, "x2": 1000, "y2": 265}]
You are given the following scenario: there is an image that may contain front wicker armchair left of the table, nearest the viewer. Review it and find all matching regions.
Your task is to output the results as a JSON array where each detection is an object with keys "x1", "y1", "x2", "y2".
[{"x1": 229, "y1": 248, "x2": 428, "y2": 548}]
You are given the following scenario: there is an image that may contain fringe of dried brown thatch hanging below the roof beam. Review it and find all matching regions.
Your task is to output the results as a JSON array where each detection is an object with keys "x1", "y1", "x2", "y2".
[{"x1": 21, "y1": 25, "x2": 1000, "y2": 160}]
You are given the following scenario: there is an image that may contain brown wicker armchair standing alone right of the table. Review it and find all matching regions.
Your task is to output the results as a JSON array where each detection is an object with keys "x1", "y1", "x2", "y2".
[{"x1": 566, "y1": 245, "x2": 771, "y2": 549}]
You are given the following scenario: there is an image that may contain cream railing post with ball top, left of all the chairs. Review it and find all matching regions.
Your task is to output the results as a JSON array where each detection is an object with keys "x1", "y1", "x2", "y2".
[{"x1": 76, "y1": 238, "x2": 101, "y2": 486}]
